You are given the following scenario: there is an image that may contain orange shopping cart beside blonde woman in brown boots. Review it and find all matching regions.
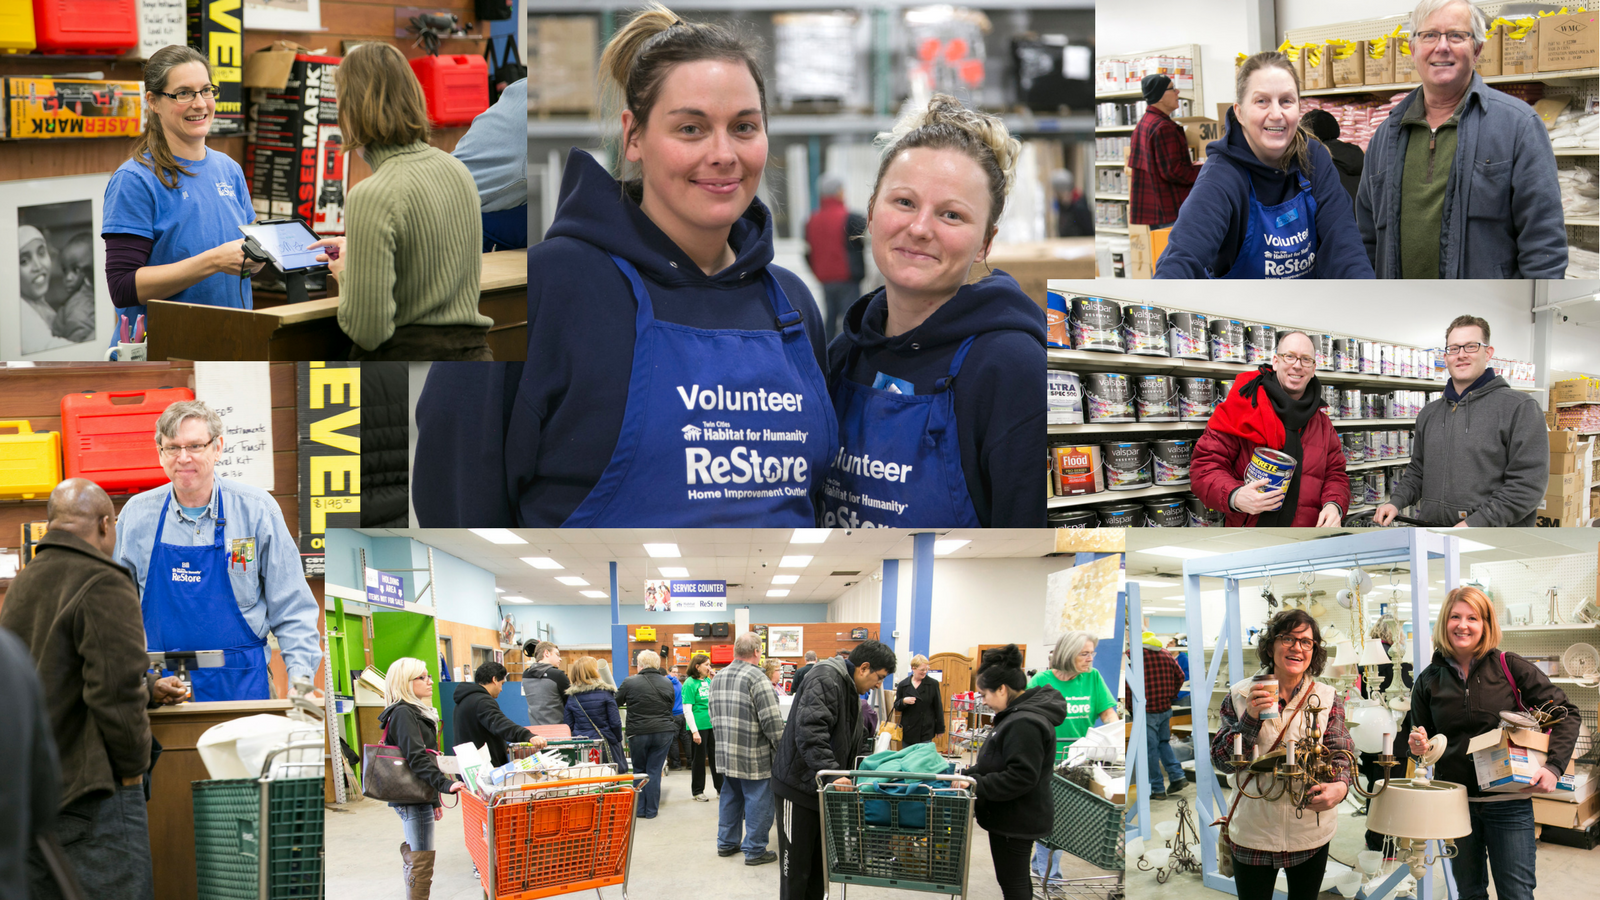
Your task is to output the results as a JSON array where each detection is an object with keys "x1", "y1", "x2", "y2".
[{"x1": 459, "y1": 768, "x2": 645, "y2": 900}]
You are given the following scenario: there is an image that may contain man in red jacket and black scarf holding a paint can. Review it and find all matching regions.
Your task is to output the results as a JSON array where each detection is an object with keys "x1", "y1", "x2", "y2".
[{"x1": 1189, "y1": 331, "x2": 1350, "y2": 528}]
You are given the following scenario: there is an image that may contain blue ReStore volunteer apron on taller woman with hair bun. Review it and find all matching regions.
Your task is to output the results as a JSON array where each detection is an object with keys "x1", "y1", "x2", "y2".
[{"x1": 563, "y1": 255, "x2": 838, "y2": 528}]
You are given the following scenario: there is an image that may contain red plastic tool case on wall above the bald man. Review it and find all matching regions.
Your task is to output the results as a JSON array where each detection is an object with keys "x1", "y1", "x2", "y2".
[{"x1": 61, "y1": 388, "x2": 195, "y2": 493}]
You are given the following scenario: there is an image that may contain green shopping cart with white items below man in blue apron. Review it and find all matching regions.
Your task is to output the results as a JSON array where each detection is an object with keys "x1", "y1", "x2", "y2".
[{"x1": 192, "y1": 736, "x2": 325, "y2": 900}]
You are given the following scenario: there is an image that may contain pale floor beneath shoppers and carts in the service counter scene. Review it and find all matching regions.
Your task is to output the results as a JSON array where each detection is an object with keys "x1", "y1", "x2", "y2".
[{"x1": 326, "y1": 759, "x2": 1107, "y2": 900}]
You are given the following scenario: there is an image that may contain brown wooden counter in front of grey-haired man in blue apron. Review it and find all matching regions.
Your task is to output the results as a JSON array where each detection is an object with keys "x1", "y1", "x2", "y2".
[{"x1": 147, "y1": 700, "x2": 326, "y2": 900}]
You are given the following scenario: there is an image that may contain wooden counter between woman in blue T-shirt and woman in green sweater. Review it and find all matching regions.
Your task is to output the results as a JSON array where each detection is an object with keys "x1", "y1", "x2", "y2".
[{"x1": 149, "y1": 250, "x2": 528, "y2": 360}]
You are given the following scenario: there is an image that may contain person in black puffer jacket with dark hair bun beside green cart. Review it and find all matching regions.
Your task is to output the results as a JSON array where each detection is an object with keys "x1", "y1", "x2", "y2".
[{"x1": 965, "y1": 644, "x2": 1067, "y2": 900}]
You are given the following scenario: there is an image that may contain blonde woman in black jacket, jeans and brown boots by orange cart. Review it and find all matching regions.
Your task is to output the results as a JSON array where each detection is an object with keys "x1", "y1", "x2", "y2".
[{"x1": 378, "y1": 657, "x2": 466, "y2": 900}]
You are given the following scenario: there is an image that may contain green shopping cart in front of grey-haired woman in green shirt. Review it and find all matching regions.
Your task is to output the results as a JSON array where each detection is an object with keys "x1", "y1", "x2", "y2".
[{"x1": 1038, "y1": 762, "x2": 1126, "y2": 900}]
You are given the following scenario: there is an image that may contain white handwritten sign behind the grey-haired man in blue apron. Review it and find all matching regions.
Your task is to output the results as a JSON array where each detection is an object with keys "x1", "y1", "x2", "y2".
[{"x1": 195, "y1": 362, "x2": 274, "y2": 493}]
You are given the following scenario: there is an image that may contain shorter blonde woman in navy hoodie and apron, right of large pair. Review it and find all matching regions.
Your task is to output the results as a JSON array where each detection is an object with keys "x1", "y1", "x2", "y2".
[{"x1": 822, "y1": 94, "x2": 1046, "y2": 528}]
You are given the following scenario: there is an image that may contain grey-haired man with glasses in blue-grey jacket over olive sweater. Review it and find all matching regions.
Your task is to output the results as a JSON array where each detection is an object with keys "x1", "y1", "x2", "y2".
[{"x1": 1355, "y1": 0, "x2": 1566, "y2": 279}]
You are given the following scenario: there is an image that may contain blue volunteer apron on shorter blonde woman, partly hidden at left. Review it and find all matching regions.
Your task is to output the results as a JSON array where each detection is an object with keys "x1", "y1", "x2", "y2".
[{"x1": 822, "y1": 335, "x2": 979, "y2": 528}]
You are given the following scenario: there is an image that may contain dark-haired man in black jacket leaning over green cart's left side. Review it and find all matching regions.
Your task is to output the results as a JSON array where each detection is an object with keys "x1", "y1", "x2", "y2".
[{"x1": 773, "y1": 641, "x2": 894, "y2": 900}]
